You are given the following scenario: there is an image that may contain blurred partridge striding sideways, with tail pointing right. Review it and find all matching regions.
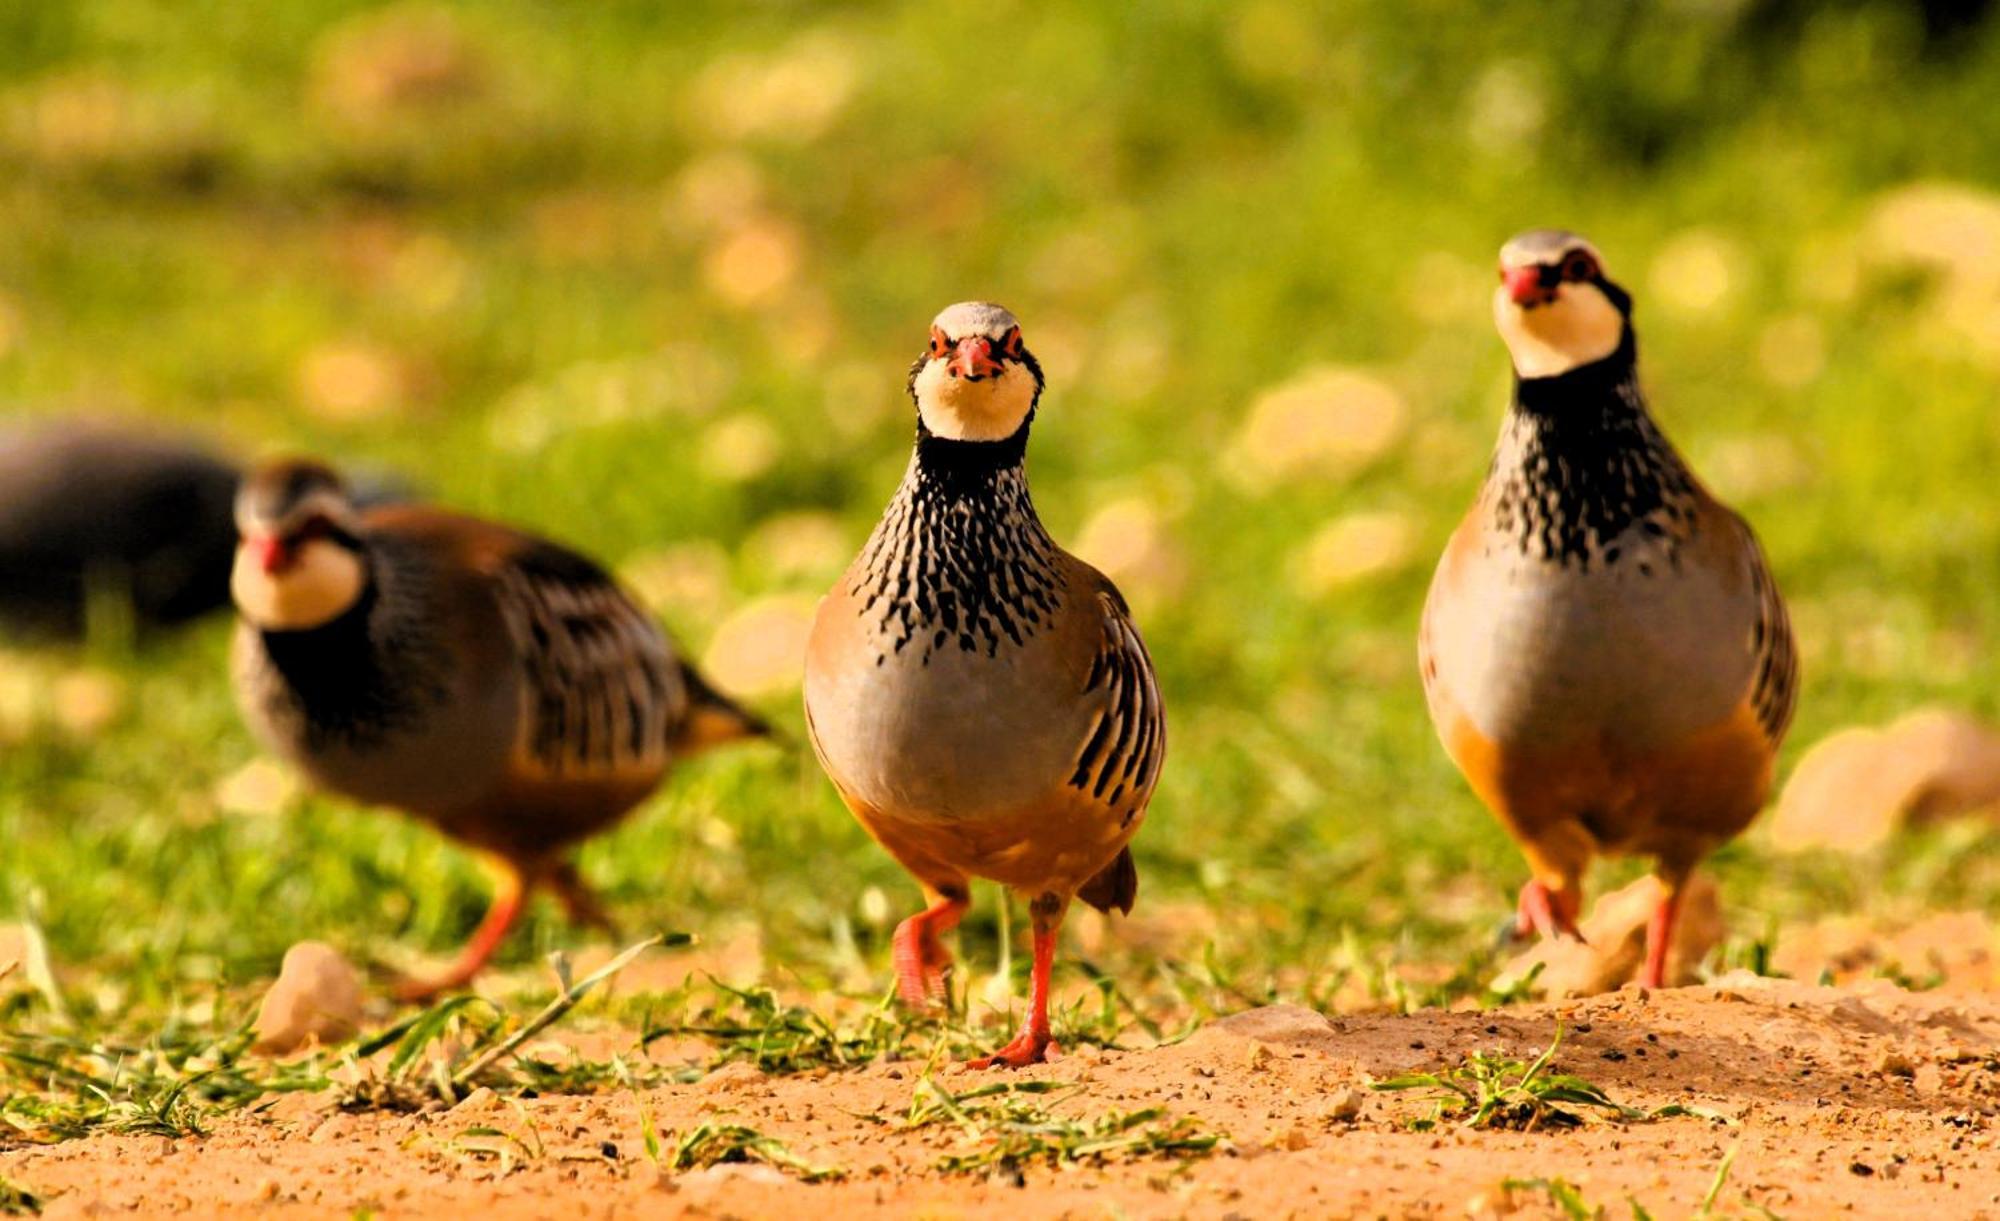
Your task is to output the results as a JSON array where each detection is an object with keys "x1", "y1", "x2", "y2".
[{"x1": 230, "y1": 462, "x2": 766, "y2": 999}]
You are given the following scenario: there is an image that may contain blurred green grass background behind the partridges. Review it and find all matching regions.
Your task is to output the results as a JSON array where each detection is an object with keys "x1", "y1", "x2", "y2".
[{"x1": 0, "y1": 0, "x2": 2000, "y2": 1007}]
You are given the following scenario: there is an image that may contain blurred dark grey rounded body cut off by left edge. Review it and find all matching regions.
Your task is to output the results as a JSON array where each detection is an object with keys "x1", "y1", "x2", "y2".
[{"x1": 0, "y1": 422, "x2": 238, "y2": 637}]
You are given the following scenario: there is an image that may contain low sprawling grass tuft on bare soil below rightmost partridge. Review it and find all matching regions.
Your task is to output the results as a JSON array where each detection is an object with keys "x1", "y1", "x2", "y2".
[{"x1": 1370, "y1": 1025, "x2": 1730, "y2": 1131}]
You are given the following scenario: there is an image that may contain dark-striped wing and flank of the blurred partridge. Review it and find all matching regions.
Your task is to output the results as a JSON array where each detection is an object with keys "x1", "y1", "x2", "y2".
[{"x1": 492, "y1": 538, "x2": 692, "y2": 779}]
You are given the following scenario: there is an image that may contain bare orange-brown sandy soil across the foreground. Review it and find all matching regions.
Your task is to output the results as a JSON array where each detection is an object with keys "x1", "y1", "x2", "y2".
[{"x1": 11, "y1": 977, "x2": 2000, "y2": 1219}]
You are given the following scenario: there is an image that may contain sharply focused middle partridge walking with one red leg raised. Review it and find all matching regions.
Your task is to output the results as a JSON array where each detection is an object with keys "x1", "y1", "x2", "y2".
[{"x1": 806, "y1": 302, "x2": 1166, "y2": 1067}]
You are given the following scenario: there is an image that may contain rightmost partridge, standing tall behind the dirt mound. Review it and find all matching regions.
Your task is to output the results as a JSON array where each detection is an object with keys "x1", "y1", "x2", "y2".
[{"x1": 1418, "y1": 230, "x2": 1798, "y2": 987}]
